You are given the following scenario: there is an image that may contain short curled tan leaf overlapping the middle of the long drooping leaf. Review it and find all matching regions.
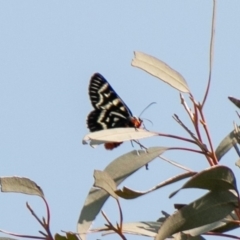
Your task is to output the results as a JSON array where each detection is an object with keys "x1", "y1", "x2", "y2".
[{"x1": 94, "y1": 170, "x2": 118, "y2": 199}]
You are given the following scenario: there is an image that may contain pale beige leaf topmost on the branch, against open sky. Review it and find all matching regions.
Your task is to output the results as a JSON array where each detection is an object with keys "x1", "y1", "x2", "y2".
[{"x1": 132, "y1": 52, "x2": 190, "y2": 93}]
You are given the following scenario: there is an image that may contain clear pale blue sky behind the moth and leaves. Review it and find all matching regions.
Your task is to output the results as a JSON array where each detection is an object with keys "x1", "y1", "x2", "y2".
[{"x1": 0, "y1": 0, "x2": 240, "y2": 239}]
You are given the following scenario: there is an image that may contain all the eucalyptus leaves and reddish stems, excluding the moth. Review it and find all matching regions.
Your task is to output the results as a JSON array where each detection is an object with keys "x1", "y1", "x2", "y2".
[{"x1": 0, "y1": 1, "x2": 240, "y2": 240}]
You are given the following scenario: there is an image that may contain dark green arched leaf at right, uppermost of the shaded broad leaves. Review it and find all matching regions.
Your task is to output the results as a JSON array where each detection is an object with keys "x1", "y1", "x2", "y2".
[{"x1": 169, "y1": 165, "x2": 238, "y2": 198}]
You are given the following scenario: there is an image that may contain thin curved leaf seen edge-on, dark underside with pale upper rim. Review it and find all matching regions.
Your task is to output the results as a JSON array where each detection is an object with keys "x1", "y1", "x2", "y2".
[{"x1": 116, "y1": 172, "x2": 196, "y2": 199}]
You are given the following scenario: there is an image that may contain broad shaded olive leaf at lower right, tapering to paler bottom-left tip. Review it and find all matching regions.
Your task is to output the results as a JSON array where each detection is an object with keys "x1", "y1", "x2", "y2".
[{"x1": 156, "y1": 191, "x2": 238, "y2": 240}]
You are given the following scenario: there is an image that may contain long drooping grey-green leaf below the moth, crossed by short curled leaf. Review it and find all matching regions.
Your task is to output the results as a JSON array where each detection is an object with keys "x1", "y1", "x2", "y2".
[{"x1": 78, "y1": 147, "x2": 168, "y2": 240}]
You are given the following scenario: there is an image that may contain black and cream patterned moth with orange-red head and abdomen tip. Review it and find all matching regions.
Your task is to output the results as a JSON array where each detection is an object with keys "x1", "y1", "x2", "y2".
[{"x1": 87, "y1": 73, "x2": 142, "y2": 150}]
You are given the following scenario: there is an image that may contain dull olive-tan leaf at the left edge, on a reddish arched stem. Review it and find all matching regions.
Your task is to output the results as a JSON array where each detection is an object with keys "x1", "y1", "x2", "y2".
[{"x1": 0, "y1": 177, "x2": 44, "y2": 197}]
